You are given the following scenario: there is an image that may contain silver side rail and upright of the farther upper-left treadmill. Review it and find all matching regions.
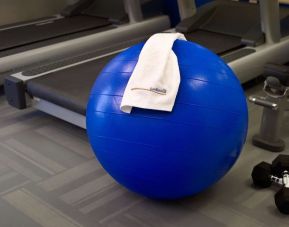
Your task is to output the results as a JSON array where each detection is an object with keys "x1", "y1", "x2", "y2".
[{"x1": 0, "y1": 0, "x2": 170, "y2": 73}]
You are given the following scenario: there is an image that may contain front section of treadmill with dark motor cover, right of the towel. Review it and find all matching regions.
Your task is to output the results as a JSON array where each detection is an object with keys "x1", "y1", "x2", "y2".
[{"x1": 176, "y1": 0, "x2": 289, "y2": 83}]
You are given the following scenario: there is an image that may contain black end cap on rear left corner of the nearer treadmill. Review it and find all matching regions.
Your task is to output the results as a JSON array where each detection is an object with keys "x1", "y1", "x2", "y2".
[{"x1": 4, "y1": 76, "x2": 27, "y2": 109}]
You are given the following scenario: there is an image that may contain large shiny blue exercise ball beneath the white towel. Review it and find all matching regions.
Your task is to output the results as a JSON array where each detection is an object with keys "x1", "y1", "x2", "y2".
[{"x1": 87, "y1": 40, "x2": 248, "y2": 199}]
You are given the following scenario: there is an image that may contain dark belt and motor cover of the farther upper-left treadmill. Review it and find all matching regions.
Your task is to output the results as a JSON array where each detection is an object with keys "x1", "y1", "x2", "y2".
[{"x1": 0, "y1": 0, "x2": 113, "y2": 57}]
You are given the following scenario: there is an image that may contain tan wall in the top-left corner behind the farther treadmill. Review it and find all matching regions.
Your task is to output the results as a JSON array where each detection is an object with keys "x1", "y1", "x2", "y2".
[{"x1": 0, "y1": 0, "x2": 72, "y2": 25}]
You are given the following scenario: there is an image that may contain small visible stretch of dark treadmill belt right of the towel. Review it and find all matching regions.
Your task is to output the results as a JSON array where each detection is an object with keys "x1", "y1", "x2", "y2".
[{"x1": 185, "y1": 30, "x2": 244, "y2": 55}]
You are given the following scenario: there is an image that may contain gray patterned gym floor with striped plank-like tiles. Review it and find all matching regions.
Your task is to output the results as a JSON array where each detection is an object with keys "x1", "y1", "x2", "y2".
[{"x1": 0, "y1": 86, "x2": 289, "y2": 227}]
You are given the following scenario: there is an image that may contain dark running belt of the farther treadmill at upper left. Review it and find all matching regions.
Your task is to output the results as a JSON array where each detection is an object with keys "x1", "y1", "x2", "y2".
[{"x1": 0, "y1": 16, "x2": 111, "y2": 51}]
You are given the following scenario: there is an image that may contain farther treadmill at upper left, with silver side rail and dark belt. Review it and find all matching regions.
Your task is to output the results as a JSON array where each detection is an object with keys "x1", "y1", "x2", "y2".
[{"x1": 0, "y1": 0, "x2": 170, "y2": 85}]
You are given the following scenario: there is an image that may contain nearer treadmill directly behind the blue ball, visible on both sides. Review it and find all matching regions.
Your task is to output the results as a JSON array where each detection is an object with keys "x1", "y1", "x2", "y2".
[{"x1": 5, "y1": 0, "x2": 289, "y2": 128}]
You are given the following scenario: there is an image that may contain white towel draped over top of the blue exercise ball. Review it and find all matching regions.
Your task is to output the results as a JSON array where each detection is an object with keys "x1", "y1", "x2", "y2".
[{"x1": 120, "y1": 33, "x2": 186, "y2": 113}]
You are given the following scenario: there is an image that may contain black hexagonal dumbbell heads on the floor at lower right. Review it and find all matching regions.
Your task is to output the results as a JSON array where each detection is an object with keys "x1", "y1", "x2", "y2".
[{"x1": 252, "y1": 155, "x2": 289, "y2": 214}]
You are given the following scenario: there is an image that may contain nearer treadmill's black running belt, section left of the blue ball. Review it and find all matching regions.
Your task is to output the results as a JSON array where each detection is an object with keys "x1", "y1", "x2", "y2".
[{"x1": 27, "y1": 54, "x2": 116, "y2": 115}]
